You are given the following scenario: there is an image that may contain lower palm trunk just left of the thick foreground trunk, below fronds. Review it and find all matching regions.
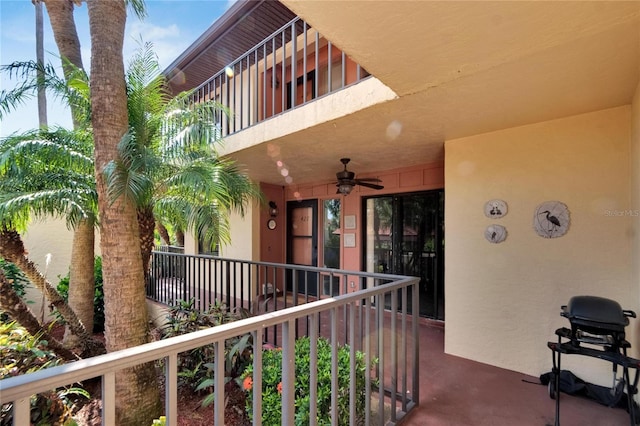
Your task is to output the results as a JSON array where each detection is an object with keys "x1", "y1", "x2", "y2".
[{"x1": 64, "y1": 220, "x2": 95, "y2": 347}]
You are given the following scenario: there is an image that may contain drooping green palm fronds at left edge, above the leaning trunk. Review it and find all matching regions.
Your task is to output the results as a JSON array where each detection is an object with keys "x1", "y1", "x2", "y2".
[{"x1": 0, "y1": 125, "x2": 97, "y2": 227}]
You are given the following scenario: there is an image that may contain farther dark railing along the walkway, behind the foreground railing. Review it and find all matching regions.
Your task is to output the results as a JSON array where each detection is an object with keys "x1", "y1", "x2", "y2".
[{"x1": 147, "y1": 251, "x2": 408, "y2": 345}]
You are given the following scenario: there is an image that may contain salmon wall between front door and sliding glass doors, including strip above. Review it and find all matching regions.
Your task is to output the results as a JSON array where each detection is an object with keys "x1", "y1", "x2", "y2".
[{"x1": 286, "y1": 163, "x2": 444, "y2": 291}]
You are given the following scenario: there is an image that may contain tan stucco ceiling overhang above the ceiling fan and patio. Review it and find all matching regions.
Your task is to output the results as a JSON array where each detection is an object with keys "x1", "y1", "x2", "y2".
[{"x1": 166, "y1": 0, "x2": 640, "y2": 185}]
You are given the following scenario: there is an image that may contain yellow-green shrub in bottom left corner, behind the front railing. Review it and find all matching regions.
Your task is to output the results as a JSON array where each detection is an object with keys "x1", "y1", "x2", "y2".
[{"x1": 0, "y1": 322, "x2": 89, "y2": 426}]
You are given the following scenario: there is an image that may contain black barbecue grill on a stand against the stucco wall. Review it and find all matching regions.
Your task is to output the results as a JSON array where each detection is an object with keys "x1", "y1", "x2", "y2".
[{"x1": 547, "y1": 296, "x2": 640, "y2": 426}]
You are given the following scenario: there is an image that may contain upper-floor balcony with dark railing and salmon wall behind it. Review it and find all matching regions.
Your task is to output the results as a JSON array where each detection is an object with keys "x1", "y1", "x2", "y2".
[{"x1": 173, "y1": 13, "x2": 370, "y2": 142}]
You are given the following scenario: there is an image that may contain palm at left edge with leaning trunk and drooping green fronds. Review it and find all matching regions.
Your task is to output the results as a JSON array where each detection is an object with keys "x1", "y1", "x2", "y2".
[{"x1": 0, "y1": 129, "x2": 104, "y2": 356}]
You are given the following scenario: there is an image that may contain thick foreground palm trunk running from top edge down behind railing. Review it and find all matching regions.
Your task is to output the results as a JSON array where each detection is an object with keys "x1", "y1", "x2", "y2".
[{"x1": 87, "y1": 0, "x2": 162, "y2": 426}]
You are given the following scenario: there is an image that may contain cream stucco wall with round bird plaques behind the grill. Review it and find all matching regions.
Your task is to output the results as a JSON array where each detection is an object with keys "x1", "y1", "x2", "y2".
[{"x1": 445, "y1": 106, "x2": 640, "y2": 383}]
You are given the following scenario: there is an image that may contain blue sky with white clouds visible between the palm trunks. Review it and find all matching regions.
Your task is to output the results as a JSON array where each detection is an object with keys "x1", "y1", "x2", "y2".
[{"x1": 0, "y1": 0, "x2": 234, "y2": 137}]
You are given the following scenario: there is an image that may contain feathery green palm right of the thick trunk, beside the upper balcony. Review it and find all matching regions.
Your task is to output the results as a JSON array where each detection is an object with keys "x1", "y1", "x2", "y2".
[{"x1": 105, "y1": 43, "x2": 262, "y2": 273}]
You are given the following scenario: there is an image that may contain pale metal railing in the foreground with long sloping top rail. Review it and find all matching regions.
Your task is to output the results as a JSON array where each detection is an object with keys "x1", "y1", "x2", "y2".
[{"x1": 0, "y1": 265, "x2": 419, "y2": 425}]
